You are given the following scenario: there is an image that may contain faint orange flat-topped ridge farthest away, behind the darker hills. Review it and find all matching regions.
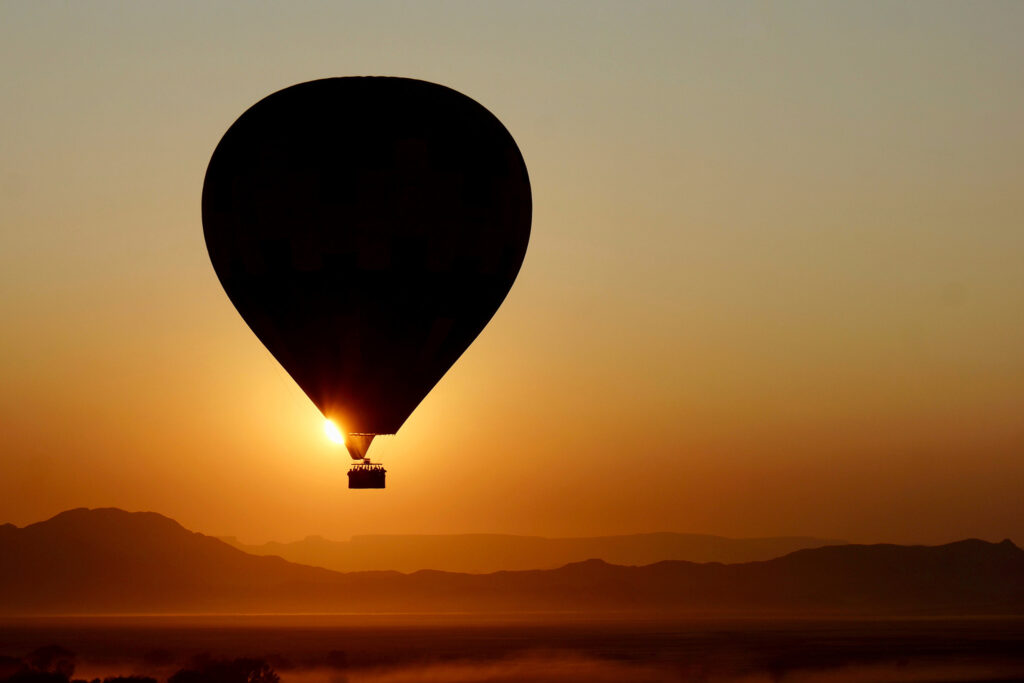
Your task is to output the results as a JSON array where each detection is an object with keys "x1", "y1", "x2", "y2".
[{"x1": 221, "y1": 533, "x2": 846, "y2": 573}]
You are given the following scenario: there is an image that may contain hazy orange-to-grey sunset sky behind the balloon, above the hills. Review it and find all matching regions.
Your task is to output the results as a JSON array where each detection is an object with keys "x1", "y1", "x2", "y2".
[{"x1": 0, "y1": 0, "x2": 1024, "y2": 544}]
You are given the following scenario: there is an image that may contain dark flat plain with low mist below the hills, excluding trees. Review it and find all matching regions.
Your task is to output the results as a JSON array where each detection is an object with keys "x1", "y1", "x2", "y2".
[{"x1": 0, "y1": 615, "x2": 1024, "y2": 683}]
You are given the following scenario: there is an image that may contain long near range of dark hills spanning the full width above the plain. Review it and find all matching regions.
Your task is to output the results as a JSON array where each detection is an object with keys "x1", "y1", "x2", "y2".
[{"x1": 0, "y1": 509, "x2": 1024, "y2": 614}]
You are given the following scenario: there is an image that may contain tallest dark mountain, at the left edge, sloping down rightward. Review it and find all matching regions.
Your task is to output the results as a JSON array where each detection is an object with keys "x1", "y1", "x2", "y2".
[{"x1": 0, "y1": 508, "x2": 346, "y2": 612}]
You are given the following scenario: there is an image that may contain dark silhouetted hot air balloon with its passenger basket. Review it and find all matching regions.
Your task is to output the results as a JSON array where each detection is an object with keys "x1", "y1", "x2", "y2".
[{"x1": 203, "y1": 77, "x2": 531, "y2": 488}]
